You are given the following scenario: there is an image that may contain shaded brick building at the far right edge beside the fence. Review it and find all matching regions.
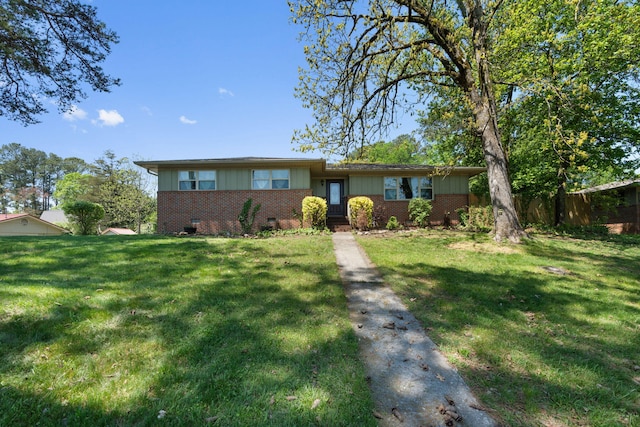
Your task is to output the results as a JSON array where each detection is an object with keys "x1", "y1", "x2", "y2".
[{"x1": 572, "y1": 179, "x2": 640, "y2": 234}]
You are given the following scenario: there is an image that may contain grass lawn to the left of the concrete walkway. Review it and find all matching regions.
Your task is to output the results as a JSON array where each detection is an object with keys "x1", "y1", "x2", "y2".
[{"x1": 0, "y1": 236, "x2": 375, "y2": 426}]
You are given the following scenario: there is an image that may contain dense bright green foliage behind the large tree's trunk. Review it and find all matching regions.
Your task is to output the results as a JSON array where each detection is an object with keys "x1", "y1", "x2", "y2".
[{"x1": 420, "y1": 0, "x2": 640, "y2": 224}]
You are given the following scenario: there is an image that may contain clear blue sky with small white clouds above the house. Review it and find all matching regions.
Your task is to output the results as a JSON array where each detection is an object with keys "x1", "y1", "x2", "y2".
[{"x1": 0, "y1": 0, "x2": 416, "y2": 162}]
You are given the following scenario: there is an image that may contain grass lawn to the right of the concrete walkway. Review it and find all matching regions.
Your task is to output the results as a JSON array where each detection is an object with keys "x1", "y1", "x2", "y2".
[{"x1": 358, "y1": 231, "x2": 640, "y2": 427}]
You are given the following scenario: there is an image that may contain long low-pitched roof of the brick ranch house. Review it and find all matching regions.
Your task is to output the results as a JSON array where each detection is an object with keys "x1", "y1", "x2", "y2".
[{"x1": 134, "y1": 157, "x2": 487, "y2": 176}]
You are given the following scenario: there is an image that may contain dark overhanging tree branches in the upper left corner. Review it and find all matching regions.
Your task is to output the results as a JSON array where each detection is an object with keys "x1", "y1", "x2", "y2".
[{"x1": 0, "y1": 0, "x2": 119, "y2": 125}]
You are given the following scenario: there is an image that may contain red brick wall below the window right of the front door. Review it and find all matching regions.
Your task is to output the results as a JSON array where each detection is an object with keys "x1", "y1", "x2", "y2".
[{"x1": 358, "y1": 194, "x2": 469, "y2": 226}]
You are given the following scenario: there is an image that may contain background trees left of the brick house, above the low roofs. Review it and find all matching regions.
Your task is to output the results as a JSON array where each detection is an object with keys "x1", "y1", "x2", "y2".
[{"x1": 0, "y1": 143, "x2": 156, "y2": 231}]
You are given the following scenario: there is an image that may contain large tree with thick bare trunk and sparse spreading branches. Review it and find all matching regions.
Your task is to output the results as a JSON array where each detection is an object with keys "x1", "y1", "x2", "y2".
[{"x1": 289, "y1": 0, "x2": 525, "y2": 242}]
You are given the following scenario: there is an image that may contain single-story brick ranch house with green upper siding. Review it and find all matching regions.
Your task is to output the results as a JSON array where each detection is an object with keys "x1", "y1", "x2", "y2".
[{"x1": 135, "y1": 157, "x2": 486, "y2": 234}]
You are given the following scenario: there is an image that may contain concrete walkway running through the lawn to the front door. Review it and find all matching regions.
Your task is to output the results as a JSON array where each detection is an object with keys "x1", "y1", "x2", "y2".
[{"x1": 333, "y1": 232, "x2": 497, "y2": 427}]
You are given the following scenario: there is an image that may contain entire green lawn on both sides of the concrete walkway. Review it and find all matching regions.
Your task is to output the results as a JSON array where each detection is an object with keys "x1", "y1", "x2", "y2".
[{"x1": 0, "y1": 231, "x2": 640, "y2": 426}]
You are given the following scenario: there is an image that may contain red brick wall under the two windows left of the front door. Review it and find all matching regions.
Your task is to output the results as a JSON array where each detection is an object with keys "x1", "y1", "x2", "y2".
[{"x1": 158, "y1": 190, "x2": 311, "y2": 234}]
